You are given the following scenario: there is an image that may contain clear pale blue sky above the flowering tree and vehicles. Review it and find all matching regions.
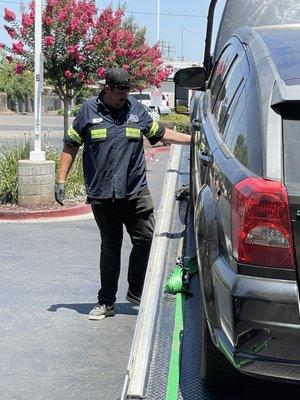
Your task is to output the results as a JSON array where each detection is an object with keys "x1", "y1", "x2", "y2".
[{"x1": 0, "y1": 0, "x2": 225, "y2": 62}]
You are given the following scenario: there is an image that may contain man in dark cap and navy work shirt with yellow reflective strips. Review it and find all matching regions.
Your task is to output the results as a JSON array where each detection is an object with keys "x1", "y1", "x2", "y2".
[{"x1": 55, "y1": 68, "x2": 190, "y2": 320}]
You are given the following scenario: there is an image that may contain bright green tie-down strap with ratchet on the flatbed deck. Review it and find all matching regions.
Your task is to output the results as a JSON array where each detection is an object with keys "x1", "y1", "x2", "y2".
[{"x1": 165, "y1": 257, "x2": 198, "y2": 400}]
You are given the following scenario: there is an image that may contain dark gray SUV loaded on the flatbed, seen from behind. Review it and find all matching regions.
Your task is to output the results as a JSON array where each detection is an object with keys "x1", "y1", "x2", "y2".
[{"x1": 175, "y1": 0, "x2": 300, "y2": 385}]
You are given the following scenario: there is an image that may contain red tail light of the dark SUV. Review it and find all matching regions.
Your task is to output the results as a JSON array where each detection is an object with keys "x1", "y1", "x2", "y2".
[{"x1": 231, "y1": 178, "x2": 295, "y2": 269}]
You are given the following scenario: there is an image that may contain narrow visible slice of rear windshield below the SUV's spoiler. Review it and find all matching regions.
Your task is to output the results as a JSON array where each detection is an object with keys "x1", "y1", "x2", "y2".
[{"x1": 282, "y1": 108, "x2": 300, "y2": 184}]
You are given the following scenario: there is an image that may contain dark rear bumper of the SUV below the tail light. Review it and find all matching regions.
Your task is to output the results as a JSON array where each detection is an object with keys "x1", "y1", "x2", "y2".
[{"x1": 211, "y1": 257, "x2": 300, "y2": 381}]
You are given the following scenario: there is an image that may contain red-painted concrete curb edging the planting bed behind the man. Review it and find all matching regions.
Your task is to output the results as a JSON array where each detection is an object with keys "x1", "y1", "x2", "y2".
[{"x1": 0, "y1": 146, "x2": 170, "y2": 221}]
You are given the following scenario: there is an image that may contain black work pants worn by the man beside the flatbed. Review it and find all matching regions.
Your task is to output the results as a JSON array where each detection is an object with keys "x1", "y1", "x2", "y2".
[{"x1": 92, "y1": 194, "x2": 154, "y2": 305}]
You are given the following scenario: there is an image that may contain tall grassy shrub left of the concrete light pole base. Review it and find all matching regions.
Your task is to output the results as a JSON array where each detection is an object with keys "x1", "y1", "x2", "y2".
[{"x1": 0, "y1": 138, "x2": 30, "y2": 204}]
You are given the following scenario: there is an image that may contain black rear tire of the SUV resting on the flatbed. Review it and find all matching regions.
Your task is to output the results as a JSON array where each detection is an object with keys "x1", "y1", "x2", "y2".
[{"x1": 200, "y1": 306, "x2": 244, "y2": 388}]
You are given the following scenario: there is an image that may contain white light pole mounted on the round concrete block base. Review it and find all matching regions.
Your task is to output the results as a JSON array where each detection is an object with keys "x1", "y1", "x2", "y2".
[{"x1": 30, "y1": 0, "x2": 46, "y2": 161}]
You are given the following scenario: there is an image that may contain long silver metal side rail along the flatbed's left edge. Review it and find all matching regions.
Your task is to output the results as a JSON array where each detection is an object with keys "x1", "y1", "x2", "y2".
[{"x1": 121, "y1": 145, "x2": 189, "y2": 400}]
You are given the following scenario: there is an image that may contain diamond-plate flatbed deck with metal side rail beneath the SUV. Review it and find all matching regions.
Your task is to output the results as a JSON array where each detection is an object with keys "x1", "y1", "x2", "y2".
[{"x1": 121, "y1": 146, "x2": 300, "y2": 400}]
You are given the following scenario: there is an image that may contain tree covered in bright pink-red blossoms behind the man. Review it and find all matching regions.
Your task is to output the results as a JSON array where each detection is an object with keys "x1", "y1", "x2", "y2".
[{"x1": 0, "y1": 0, "x2": 169, "y2": 133}]
